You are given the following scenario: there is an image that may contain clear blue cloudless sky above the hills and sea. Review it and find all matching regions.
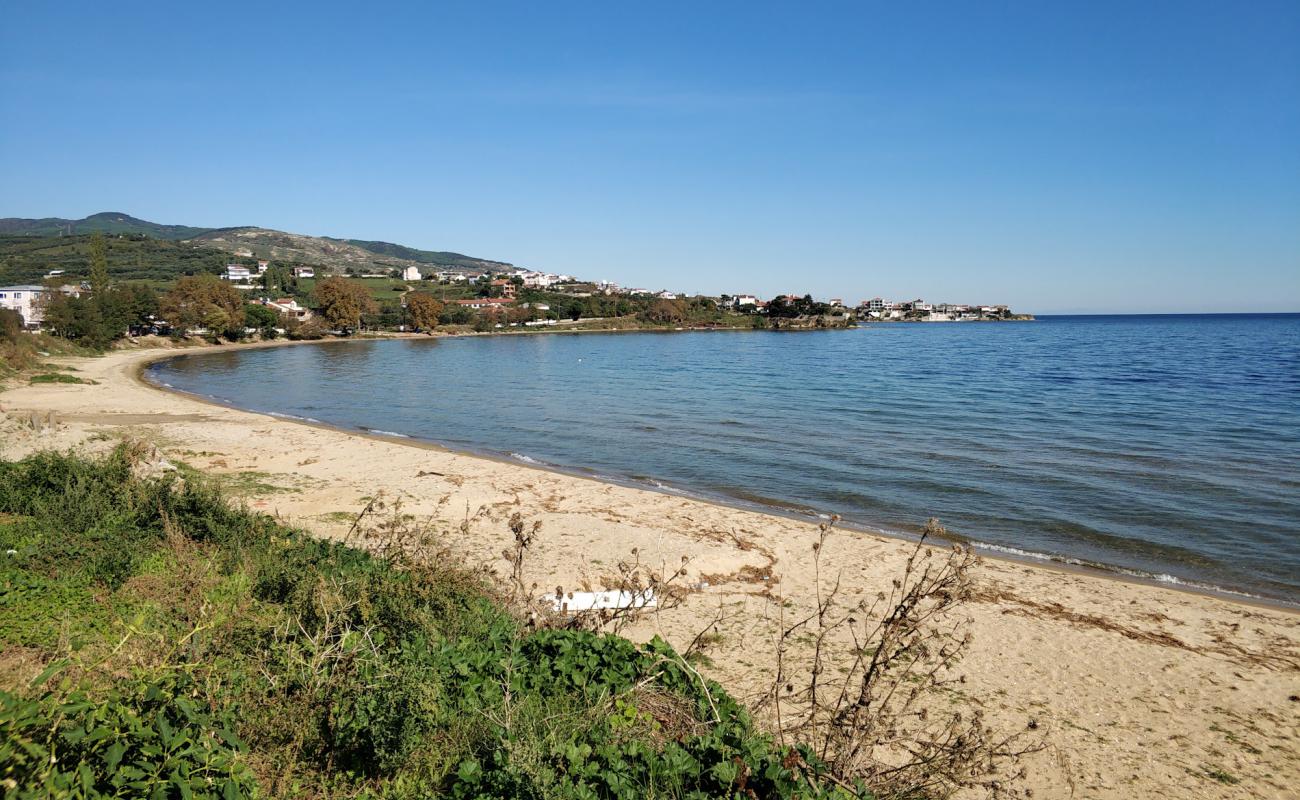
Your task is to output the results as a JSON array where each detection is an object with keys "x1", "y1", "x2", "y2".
[{"x1": 0, "y1": 0, "x2": 1300, "y2": 313}]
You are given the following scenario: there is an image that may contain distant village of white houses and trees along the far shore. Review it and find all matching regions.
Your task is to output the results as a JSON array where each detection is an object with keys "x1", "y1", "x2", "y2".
[{"x1": 0, "y1": 248, "x2": 1032, "y2": 338}]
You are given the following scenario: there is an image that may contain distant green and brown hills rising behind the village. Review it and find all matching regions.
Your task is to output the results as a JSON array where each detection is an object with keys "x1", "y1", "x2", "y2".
[{"x1": 0, "y1": 212, "x2": 511, "y2": 282}]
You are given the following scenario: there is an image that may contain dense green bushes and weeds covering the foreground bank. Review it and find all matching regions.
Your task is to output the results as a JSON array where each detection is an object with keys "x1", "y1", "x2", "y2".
[{"x1": 0, "y1": 445, "x2": 866, "y2": 799}]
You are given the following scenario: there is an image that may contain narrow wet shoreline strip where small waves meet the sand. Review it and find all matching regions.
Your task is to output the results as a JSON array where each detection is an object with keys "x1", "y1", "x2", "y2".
[{"x1": 133, "y1": 338, "x2": 1300, "y2": 615}]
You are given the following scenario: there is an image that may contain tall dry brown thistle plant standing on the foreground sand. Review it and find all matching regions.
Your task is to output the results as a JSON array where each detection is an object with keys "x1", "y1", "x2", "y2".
[{"x1": 758, "y1": 520, "x2": 1040, "y2": 800}]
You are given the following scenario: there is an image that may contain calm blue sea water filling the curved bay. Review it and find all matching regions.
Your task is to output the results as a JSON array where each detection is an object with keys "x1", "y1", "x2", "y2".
[{"x1": 152, "y1": 315, "x2": 1300, "y2": 602}]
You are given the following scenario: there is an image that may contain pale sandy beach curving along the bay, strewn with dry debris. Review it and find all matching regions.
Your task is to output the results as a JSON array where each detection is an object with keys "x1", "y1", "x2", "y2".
[{"x1": 0, "y1": 340, "x2": 1300, "y2": 799}]
